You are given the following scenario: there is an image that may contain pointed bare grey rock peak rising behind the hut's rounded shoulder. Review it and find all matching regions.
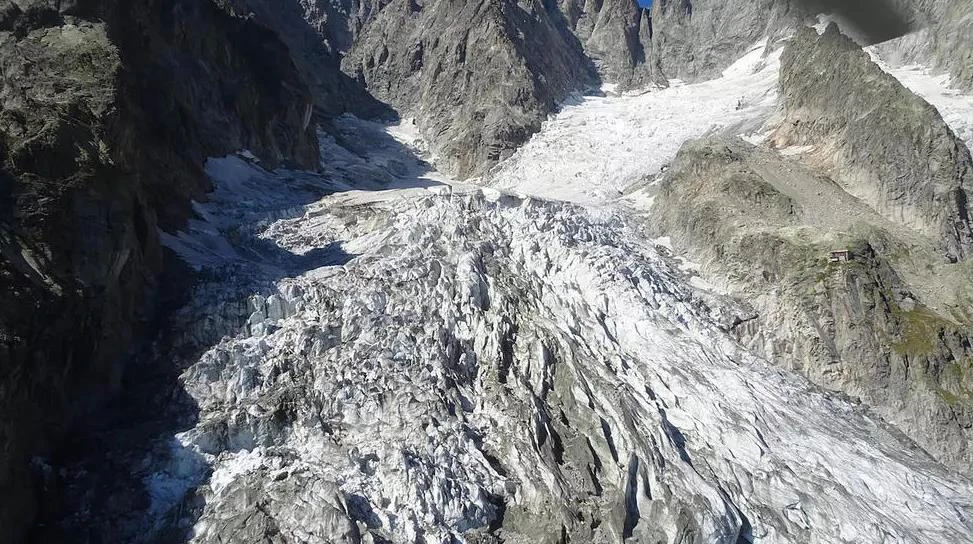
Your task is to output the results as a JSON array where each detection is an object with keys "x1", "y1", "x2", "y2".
[{"x1": 773, "y1": 24, "x2": 973, "y2": 259}]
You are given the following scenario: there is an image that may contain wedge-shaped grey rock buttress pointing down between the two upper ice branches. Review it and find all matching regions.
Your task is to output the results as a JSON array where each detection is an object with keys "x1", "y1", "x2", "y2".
[{"x1": 342, "y1": 0, "x2": 597, "y2": 177}]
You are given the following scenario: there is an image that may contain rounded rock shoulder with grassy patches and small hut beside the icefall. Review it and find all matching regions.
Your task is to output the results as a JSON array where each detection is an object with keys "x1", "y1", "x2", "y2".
[{"x1": 653, "y1": 138, "x2": 973, "y2": 473}]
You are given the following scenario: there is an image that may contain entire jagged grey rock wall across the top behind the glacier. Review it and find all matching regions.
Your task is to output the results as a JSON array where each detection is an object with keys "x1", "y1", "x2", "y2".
[{"x1": 220, "y1": 0, "x2": 971, "y2": 178}]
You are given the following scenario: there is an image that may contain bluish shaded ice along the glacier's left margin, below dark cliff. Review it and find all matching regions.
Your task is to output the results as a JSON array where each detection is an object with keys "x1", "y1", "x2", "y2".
[{"x1": 131, "y1": 115, "x2": 441, "y2": 543}]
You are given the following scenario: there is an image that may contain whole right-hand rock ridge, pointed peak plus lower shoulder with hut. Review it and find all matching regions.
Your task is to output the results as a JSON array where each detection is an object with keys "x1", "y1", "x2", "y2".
[{"x1": 653, "y1": 25, "x2": 973, "y2": 472}]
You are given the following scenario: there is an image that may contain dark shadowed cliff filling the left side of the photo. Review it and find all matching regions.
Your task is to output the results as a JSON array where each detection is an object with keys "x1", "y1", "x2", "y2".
[{"x1": 0, "y1": 0, "x2": 317, "y2": 542}]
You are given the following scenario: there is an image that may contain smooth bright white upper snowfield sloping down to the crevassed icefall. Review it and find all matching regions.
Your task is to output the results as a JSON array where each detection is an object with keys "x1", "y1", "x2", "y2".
[{"x1": 487, "y1": 40, "x2": 781, "y2": 203}]
